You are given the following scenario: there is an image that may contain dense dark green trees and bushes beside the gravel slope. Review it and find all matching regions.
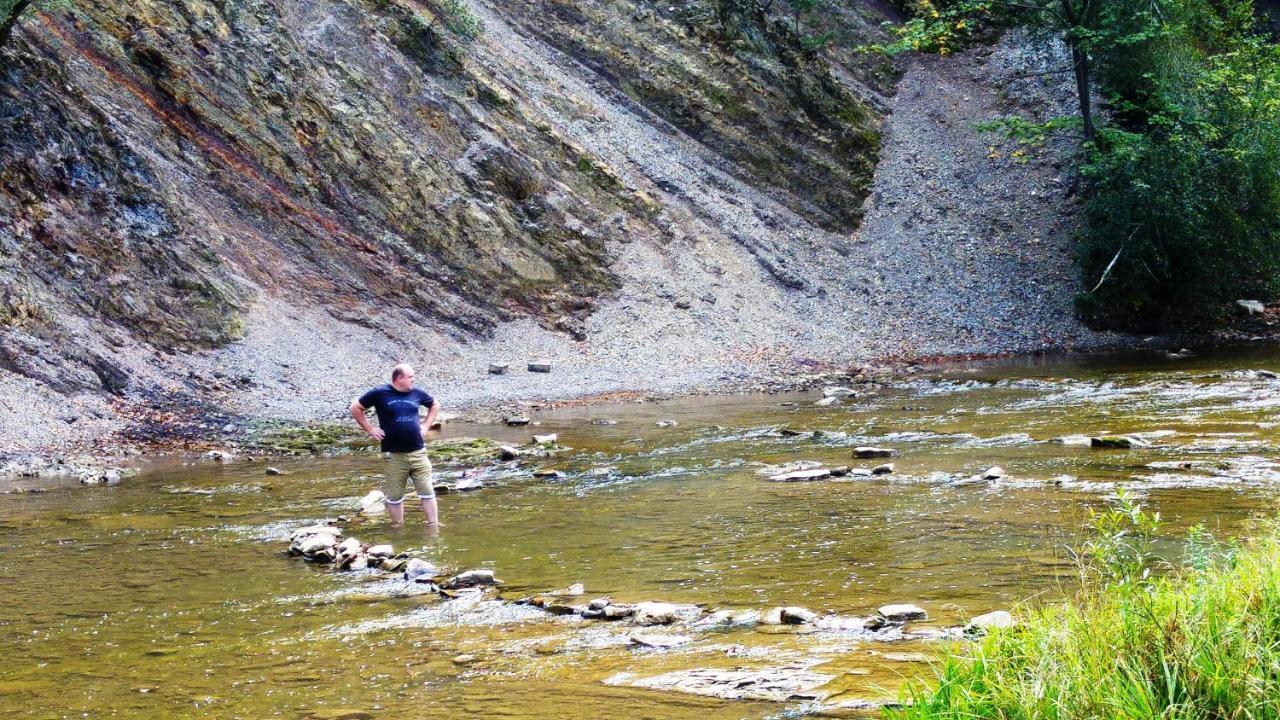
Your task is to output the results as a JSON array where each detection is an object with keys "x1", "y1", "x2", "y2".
[{"x1": 1078, "y1": 0, "x2": 1280, "y2": 329}]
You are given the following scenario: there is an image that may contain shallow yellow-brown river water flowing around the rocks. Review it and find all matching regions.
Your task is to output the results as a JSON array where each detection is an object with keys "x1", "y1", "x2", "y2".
[{"x1": 0, "y1": 351, "x2": 1280, "y2": 720}]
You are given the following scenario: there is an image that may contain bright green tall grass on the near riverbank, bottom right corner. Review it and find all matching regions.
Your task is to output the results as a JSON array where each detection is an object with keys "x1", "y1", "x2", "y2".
[{"x1": 886, "y1": 497, "x2": 1280, "y2": 720}]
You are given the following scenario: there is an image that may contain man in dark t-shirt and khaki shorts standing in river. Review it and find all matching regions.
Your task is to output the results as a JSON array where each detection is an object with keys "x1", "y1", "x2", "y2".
[{"x1": 351, "y1": 363, "x2": 440, "y2": 527}]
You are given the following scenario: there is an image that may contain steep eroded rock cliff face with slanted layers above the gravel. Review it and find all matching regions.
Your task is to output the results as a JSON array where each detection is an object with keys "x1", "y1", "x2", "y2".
[{"x1": 0, "y1": 0, "x2": 892, "y2": 407}]
